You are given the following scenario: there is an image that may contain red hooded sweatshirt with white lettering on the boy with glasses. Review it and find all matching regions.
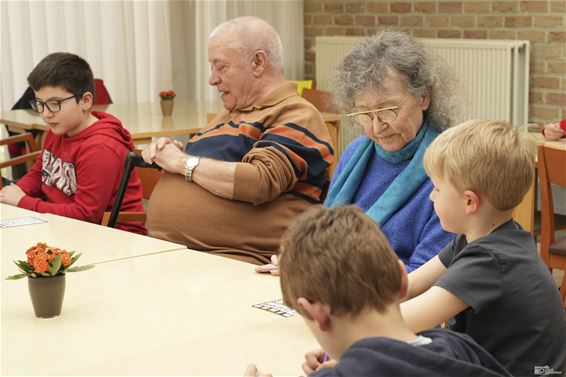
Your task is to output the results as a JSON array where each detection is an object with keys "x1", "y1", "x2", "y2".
[{"x1": 17, "y1": 112, "x2": 147, "y2": 234}]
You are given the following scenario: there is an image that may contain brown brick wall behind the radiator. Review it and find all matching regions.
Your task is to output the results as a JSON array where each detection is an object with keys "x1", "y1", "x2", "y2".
[{"x1": 304, "y1": 0, "x2": 566, "y2": 124}]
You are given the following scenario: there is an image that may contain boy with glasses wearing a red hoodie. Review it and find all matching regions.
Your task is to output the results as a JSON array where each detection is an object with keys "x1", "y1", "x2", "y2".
[{"x1": 0, "y1": 53, "x2": 147, "y2": 234}]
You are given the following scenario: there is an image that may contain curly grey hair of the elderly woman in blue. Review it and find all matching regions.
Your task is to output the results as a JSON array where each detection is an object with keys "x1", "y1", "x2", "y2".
[{"x1": 334, "y1": 31, "x2": 461, "y2": 128}]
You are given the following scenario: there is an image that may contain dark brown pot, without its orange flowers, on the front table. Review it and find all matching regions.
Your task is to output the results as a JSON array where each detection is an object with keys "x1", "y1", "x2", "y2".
[{"x1": 28, "y1": 275, "x2": 65, "y2": 318}]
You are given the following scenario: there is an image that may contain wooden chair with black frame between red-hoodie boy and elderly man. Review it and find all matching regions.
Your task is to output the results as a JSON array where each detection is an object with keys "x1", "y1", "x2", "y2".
[{"x1": 101, "y1": 150, "x2": 163, "y2": 228}]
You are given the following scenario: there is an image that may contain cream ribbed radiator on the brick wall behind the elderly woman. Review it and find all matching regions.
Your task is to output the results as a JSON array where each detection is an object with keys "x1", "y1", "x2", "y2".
[{"x1": 316, "y1": 36, "x2": 529, "y2": 154}]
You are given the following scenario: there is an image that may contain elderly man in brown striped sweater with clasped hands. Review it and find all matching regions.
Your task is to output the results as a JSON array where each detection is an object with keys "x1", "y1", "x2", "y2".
[{"x1": 143, "y1": 17, "x2": 334, "y2": 264}]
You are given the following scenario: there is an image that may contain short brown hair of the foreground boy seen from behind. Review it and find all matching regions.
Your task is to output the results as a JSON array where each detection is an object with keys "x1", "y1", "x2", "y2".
[{"x1": 280, "y1": 205, "x2": 401, "y2": 318}]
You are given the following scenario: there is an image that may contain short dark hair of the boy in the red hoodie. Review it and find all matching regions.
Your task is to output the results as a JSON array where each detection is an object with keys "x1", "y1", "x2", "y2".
[{"x1": 28, "y1": 52, "x2": 95, "y2": 96}]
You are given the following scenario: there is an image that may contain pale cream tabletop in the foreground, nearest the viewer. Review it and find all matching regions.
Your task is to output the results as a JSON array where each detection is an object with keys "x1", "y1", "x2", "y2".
[{"x1": 0, "y1": 250, "x2": 318, "y2": 376}]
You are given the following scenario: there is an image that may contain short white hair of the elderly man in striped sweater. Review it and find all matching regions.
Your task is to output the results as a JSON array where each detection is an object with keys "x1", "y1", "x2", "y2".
[{"x1": 208, "y1": 17, "x2": 284, "y2": 73}]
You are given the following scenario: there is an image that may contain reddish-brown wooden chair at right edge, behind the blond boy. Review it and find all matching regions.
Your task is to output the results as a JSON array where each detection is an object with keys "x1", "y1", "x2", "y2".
[{"x1": 538, "y1": 144, "x2": 566, "y2": 307}]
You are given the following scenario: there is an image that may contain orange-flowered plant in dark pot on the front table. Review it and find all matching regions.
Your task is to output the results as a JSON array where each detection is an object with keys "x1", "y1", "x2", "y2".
[{"x1": 6, "y1": 242, "x2": 94, "y2": 318}]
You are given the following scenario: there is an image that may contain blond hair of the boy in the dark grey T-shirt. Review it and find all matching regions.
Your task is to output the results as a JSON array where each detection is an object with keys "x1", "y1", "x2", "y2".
[{"x1": 423, "y1": 120, "x2": 536, "y2": 210}]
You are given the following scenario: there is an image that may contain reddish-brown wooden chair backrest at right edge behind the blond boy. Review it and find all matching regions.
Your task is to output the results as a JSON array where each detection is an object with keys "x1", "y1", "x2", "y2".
[{"x1": 537, "y1": 144, "x2": 566, "y2": 265}]
